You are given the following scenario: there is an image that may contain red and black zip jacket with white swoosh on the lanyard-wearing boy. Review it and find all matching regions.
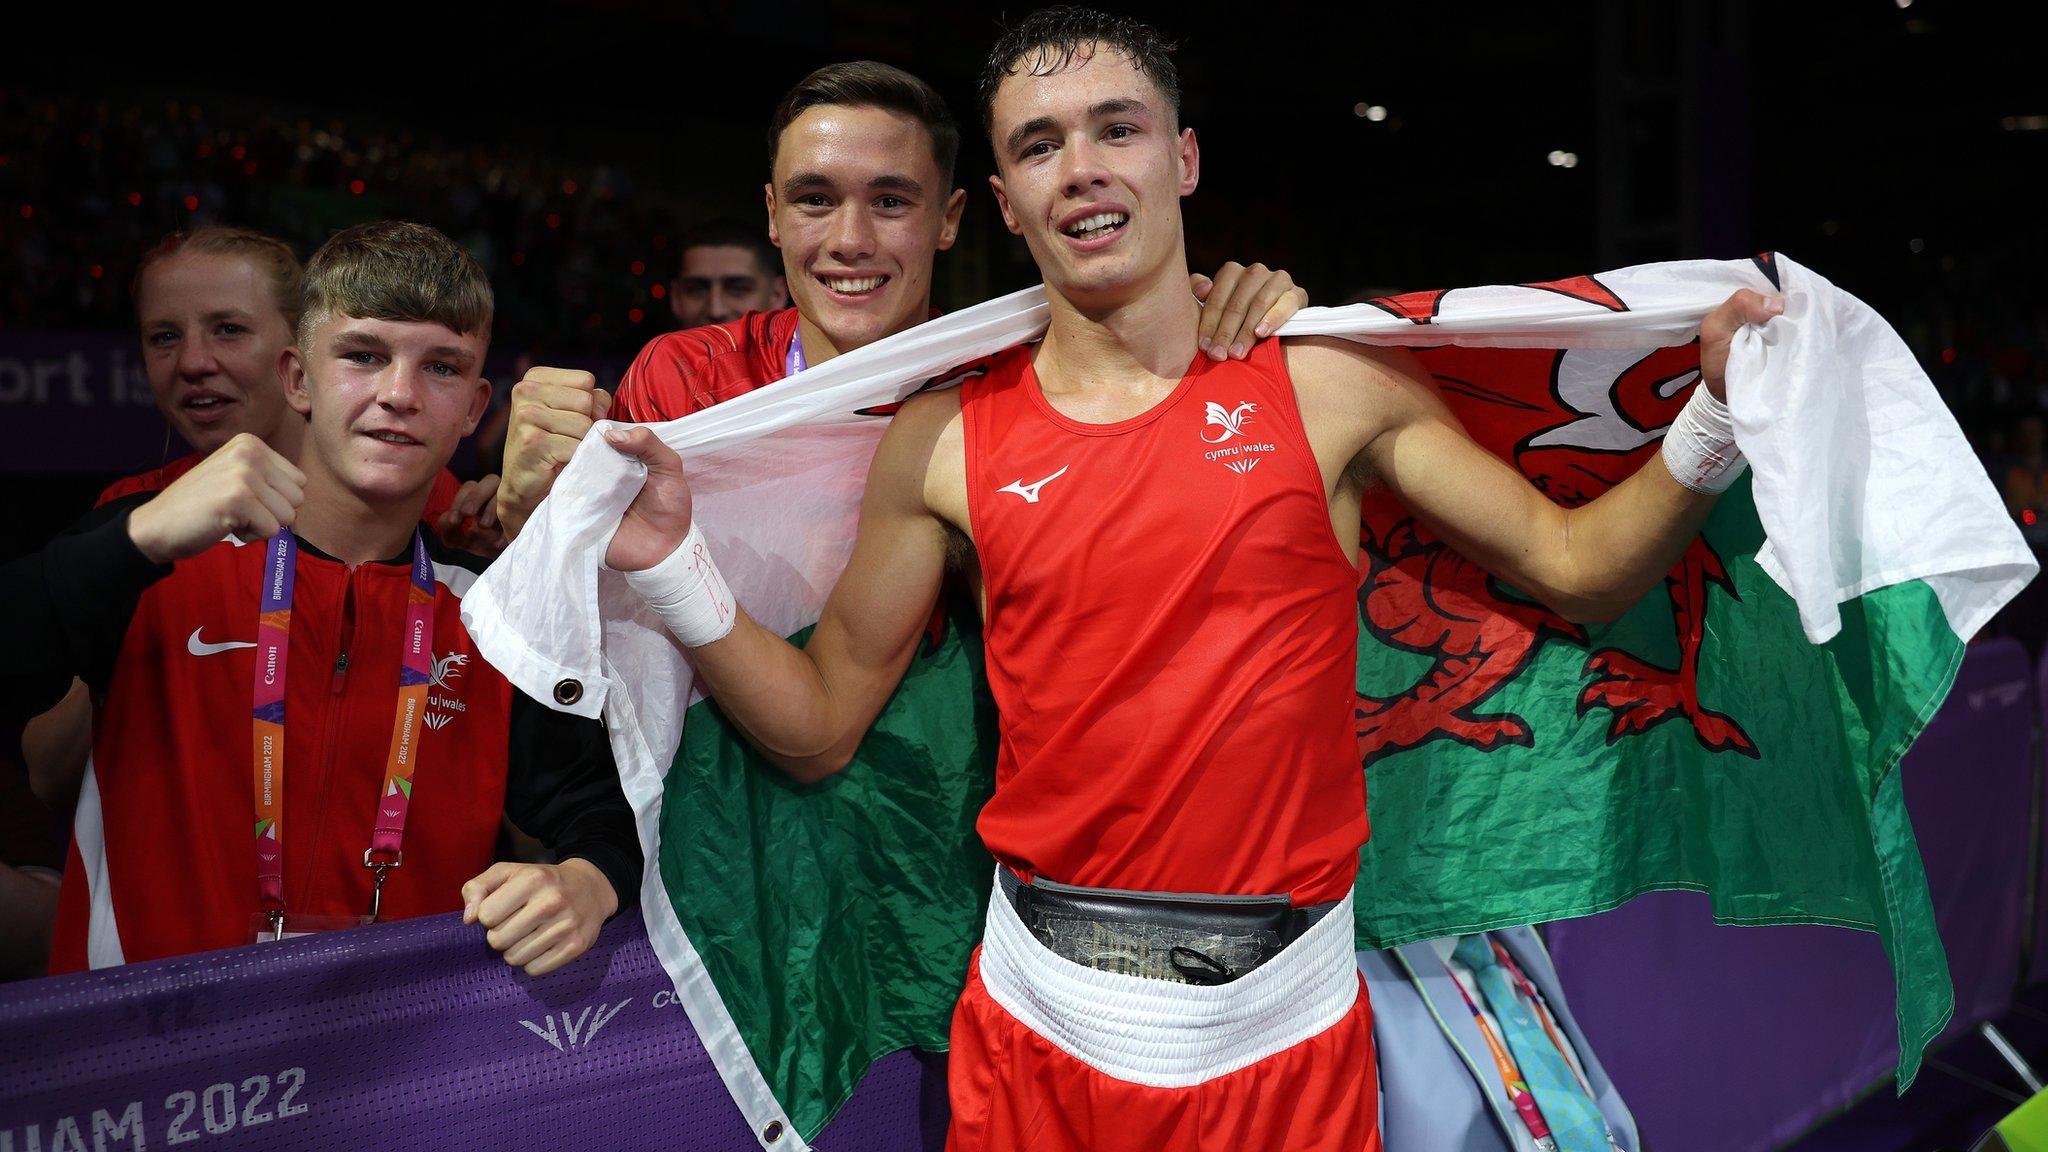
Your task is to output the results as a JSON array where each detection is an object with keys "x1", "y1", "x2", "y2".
[{"x1": 36, "y1": 496, "x2": 641, "y2": 972}]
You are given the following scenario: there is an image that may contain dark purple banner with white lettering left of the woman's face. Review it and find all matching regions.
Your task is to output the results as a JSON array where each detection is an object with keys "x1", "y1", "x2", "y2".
[{"x1": 0, "y1": 332, "x2": 174, "y2": 471}]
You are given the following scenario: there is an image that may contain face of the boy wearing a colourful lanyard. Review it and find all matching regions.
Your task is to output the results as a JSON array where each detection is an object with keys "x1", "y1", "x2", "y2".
[{"x1": 283, "y1": 314, "x2": 492, "y2": 504}]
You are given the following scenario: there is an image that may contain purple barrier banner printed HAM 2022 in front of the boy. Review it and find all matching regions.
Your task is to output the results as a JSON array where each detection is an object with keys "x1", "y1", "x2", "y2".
[{"x1": 0, "y1": 914, "x2": 944, "y2": 1152}]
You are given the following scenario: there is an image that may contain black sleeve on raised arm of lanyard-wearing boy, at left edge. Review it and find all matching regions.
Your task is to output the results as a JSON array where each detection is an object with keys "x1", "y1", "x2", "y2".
[{"x1": 0, "y1": 500, "x2": 170, "y2": 724}]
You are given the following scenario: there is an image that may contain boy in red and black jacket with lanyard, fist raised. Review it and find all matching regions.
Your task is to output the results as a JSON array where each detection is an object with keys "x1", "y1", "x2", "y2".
[{"x1": 16, "y1": 223, "x2": 641, "y2": 974}]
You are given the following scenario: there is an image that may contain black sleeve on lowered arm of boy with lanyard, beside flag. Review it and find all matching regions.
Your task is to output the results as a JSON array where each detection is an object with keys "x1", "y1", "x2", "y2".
[{"x1": 506, "y1": 689, "x2": 641, "y2": 912}]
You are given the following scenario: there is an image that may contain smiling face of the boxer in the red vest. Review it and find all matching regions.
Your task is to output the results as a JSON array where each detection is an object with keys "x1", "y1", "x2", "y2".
[{"x1": 989, "y1": 47, "x2": 1200, "y2": 305}]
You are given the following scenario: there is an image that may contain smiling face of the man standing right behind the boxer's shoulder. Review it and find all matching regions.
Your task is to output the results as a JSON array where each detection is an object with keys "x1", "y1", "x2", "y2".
[{"x1": 768, "y1": 105, "x2": 967, "y2": 363}]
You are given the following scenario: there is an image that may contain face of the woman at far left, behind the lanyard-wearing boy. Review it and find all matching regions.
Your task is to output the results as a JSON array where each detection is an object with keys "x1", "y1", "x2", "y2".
[{"x1": 135, "y1": 252, "x2": 303, "y2": 455}]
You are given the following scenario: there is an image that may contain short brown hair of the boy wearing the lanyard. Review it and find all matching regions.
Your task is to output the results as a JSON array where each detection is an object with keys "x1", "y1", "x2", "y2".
[{"x1": 297, "y1": 219, "x2": 494, "y2": 348}]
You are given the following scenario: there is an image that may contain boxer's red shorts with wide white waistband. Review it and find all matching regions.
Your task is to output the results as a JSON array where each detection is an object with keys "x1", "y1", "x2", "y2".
[{"x1": 946, "y1": 873, "x2": 1380, "y2": 1152}]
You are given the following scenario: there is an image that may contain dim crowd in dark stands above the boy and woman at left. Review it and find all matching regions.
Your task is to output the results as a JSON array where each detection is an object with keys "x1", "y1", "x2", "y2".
[{"x1": 0, "y1": 88, "x2": 696, "y2": 355}]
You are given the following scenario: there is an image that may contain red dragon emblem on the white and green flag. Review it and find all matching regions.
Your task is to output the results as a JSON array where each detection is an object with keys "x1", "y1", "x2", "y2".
[{"x1": 1356, "y1": 277, "x2": 1757, "y2": 765}]
